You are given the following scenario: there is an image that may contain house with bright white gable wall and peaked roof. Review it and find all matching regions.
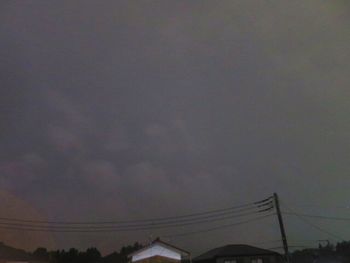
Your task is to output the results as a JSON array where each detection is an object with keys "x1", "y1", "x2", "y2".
[{"x1": 129, "y1": 238, "x2": 190, "y2": 263}]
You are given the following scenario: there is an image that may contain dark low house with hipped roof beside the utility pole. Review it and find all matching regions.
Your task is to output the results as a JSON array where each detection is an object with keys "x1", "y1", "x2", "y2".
[{"x1": 193, "y1": 245, "x2": 283, "y2": 263}]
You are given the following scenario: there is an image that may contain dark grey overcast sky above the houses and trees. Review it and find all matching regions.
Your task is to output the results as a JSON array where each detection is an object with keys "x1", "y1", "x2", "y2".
[{"x1": 0, "y1": 0, "x2": 350, "y2": 258}]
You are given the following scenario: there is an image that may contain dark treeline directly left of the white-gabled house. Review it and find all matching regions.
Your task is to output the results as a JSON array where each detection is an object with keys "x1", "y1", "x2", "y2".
[{"x1": 32, "y1": 242, "x2": 142, "y2": 263}]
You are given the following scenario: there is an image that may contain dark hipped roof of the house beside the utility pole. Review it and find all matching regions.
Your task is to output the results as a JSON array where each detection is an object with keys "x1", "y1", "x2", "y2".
[{"x1": 194, "y1": 245, "x2": 279, "y2": 261}]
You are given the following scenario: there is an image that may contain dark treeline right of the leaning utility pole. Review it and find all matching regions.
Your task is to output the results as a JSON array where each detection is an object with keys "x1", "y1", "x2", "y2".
[{"x1": 291, "y1": 241, "x2": 350, "y2": 263}]
